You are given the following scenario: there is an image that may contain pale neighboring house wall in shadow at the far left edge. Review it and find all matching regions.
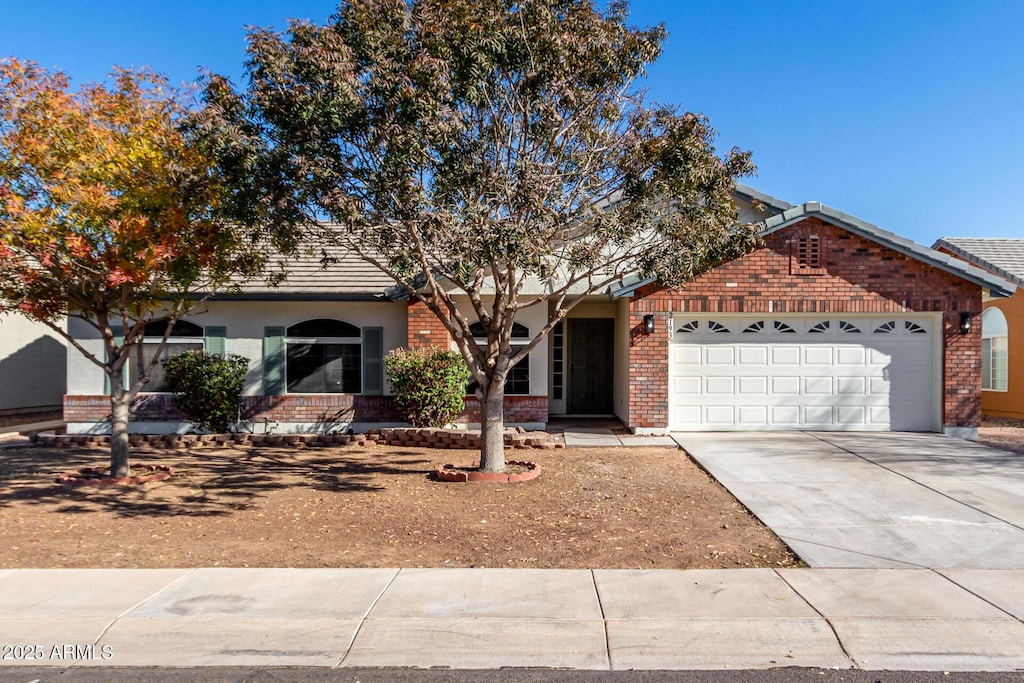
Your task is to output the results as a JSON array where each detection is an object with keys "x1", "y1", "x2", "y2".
[{"x1": 0, "y1": 313, "x2": 68, "y2": 414}]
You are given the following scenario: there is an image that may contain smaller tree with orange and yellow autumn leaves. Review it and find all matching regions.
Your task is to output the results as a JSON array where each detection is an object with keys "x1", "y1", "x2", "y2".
[{"x1": 0, "y1": 59, "x2": 276, "y2": 476}]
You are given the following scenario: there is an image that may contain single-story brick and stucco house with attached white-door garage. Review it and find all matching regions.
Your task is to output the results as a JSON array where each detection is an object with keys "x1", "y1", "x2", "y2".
[{"x1": 65, "y1": 186, "x2": 1014, "y2": 437}]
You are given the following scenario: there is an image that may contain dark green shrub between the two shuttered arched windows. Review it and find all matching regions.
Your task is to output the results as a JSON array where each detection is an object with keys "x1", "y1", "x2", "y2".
[{"x1": 161, "y1": 351, "x2": 249, "y2": 433}]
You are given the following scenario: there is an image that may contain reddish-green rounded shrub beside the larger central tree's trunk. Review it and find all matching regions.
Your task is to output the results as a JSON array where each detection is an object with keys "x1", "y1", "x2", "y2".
[{"x1": 384, "y1": 347, "x2": 470, "y2": 427}]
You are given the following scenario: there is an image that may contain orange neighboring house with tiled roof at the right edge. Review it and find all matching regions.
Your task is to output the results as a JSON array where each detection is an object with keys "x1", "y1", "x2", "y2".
[{"x1": 933, "y1": 238, "x2": 1024, "y2": 420}]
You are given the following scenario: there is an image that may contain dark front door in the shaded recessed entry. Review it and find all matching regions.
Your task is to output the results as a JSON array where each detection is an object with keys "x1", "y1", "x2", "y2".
[{"x1": 567, "y1": 317, "x2": 615, "y2": 415}]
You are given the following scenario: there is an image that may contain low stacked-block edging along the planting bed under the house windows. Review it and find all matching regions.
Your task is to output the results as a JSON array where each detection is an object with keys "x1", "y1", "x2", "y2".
[{"x1": 36, "y1": 427, "x2": 565, "y2": 451}]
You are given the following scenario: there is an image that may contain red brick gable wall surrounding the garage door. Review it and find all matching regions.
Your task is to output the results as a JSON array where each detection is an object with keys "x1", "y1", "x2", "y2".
[{"x1": 628, "y1": 217, "x2": 981, "y2": 428}]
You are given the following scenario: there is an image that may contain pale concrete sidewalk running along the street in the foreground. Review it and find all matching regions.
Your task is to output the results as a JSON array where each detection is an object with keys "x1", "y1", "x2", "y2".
[{"x1": 0, "y1": 568, "x2": 1024, "y2": 671}]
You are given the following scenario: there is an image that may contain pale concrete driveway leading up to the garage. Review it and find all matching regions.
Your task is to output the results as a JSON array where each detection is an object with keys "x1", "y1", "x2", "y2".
[{"x1": 673, "y1": 432, "x2": 1024, "y2": 569}]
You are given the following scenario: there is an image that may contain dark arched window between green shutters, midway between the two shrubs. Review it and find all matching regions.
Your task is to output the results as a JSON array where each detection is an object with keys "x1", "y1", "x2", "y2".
[{"x1": 285, "y1": 318, "x2": 362, "y2": 393}]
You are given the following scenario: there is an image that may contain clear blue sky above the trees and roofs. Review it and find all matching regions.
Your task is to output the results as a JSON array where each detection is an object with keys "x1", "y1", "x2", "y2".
[{"x1": 0, "y1": 0, "x2": 1024, "y2": 245}]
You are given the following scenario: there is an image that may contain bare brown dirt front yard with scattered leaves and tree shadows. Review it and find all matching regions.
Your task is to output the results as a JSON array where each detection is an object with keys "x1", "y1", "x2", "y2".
[{"x1": 0, "y1": 446, "x2": 795, "y2": 568}]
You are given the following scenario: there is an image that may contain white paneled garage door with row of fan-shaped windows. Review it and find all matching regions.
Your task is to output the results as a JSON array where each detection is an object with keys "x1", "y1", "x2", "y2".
[{"x1": 669, "y1": 313, "x2": 939, "y2": 431}]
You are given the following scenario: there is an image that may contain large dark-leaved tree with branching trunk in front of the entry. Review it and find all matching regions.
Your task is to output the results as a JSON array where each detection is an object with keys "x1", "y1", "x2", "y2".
[{"x1": 206, "y1": 0, "x2": 755, "y2": 469}]
